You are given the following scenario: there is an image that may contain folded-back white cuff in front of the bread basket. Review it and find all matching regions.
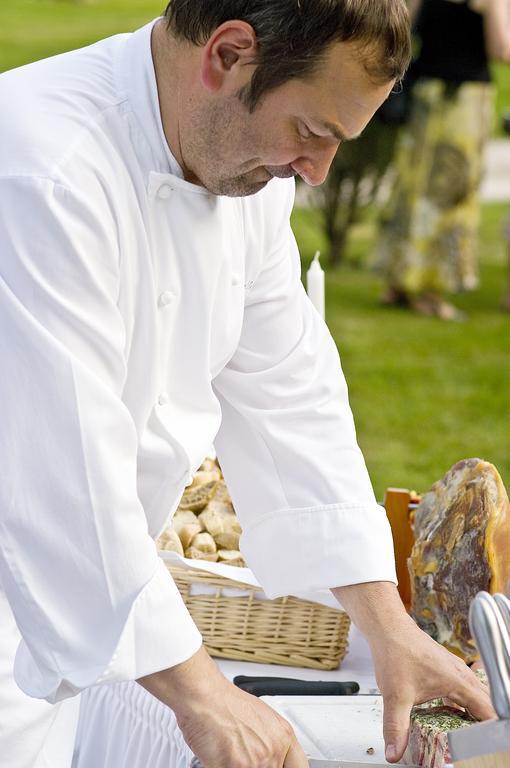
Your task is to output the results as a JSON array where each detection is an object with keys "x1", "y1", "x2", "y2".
[{"x1": 241, "y1": 504, "x2": 397, "y2": 598}]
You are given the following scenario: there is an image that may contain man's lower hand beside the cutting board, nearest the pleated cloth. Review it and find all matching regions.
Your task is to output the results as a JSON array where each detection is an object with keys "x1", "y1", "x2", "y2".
[{"x1": 138, "y1": 648, "x2": 308, "y2": 768}]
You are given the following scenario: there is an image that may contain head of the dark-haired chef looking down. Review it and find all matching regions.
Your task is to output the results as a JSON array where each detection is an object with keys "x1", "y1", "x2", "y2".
[{"x1": 160, "y1": 0, "x2": 410, "y2": 196}]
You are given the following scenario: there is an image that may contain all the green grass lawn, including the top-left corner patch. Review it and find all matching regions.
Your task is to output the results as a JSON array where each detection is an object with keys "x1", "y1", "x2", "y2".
[{"x1": 0, "y1": 0, "x2": 510, "y2": 496}]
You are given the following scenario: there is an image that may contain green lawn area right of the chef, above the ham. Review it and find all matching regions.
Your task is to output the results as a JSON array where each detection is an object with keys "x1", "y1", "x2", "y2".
[{"x1": 293, "y1": 205, "x2": 510, "y2": 496}]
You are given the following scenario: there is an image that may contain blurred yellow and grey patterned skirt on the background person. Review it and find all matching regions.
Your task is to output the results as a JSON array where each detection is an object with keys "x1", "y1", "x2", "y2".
[{"x1": 377, "y1": 80, "x2": 493, "y2": 296}]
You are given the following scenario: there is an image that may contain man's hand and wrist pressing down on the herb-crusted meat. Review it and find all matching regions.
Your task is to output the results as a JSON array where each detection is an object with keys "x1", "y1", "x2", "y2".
[{"x1": 333, "y1": 582, "x2": 495, "y2": 763}]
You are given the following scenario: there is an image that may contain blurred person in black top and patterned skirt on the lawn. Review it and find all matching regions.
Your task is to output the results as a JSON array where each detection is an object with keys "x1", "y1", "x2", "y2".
[{"x1": 377, "y1": 0, "x2": 510, "y2": 320}]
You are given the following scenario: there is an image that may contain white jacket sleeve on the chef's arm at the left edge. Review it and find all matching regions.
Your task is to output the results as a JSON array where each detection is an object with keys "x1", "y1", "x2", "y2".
[{"x1": 0, "y1": 177, "x2": 201, "y2": 702}]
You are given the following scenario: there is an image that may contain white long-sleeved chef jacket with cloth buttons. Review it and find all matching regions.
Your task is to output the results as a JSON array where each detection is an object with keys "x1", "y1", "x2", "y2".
[{"x1": 0, "y1": 22, "x2": 395, "y2": 702}]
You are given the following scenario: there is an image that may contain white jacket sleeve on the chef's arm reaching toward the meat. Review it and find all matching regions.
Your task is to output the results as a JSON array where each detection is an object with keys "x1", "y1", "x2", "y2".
[{"x1": 215, "y1": 182, "x2": 396, "y2": 597}]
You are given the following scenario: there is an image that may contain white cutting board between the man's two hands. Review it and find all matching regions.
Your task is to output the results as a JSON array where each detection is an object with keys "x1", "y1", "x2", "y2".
[{"x1": 264, "y1": 696, "x2": 389, "y2": 765}]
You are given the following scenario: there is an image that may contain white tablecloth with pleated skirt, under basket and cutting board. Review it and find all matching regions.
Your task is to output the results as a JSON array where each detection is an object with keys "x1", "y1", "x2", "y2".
[{"x1": 73, "y1": 627, "x2": 376, "y2": 768}]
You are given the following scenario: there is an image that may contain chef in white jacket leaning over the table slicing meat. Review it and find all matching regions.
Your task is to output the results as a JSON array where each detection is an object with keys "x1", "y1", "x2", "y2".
[{"x1": 0, "y1": 0, "x2": 491, "y2": 768}]
